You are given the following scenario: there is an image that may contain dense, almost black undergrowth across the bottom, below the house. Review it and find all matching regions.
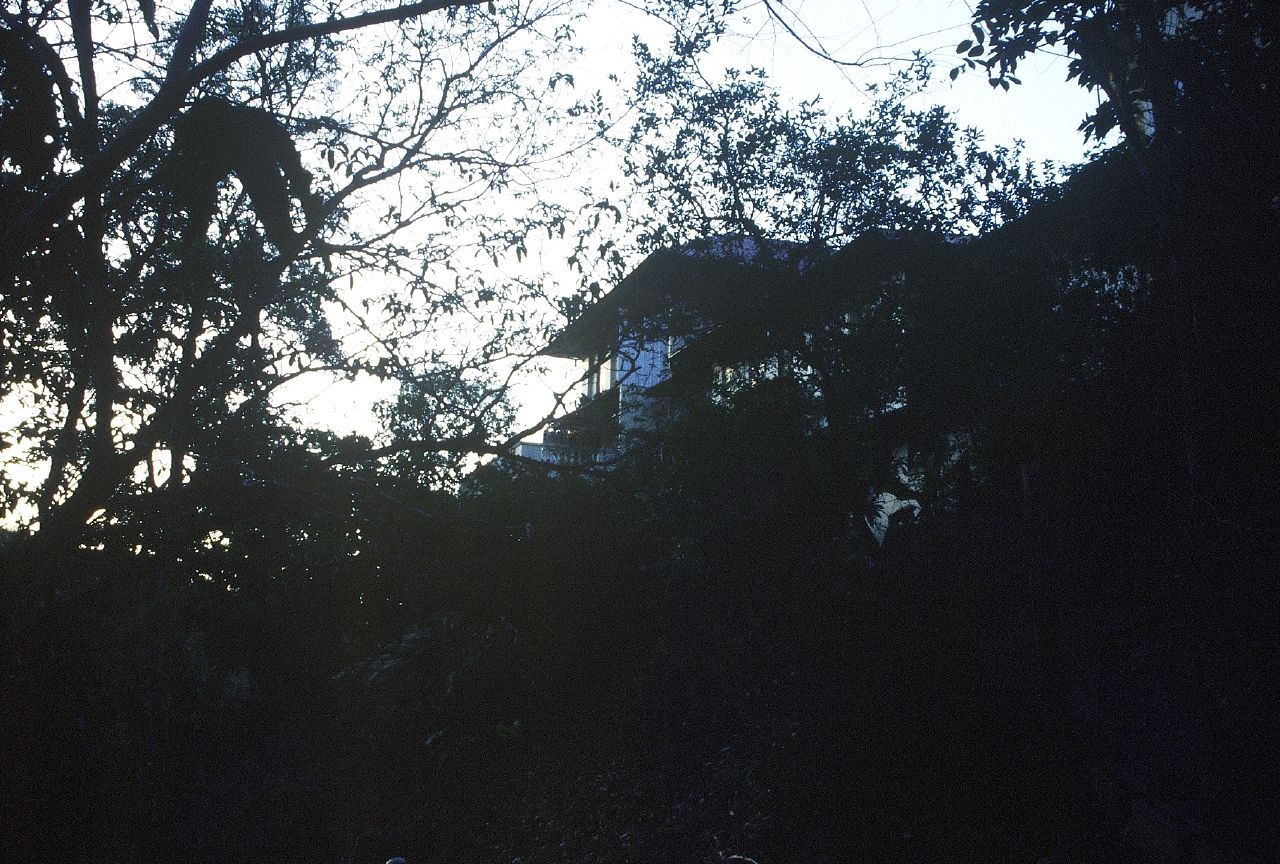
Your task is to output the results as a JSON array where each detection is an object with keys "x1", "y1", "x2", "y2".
[{"x1": 3, "y1": 479, "x2": 1280, "y2": 863}]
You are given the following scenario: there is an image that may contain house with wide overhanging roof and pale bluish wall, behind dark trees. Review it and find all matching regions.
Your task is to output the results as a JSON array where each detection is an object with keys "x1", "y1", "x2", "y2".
[{"x1": 521, "y1": 226, "x2": 998, "y2": 543}]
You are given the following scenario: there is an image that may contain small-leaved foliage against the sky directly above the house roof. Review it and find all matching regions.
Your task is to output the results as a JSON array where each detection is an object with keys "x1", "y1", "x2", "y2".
[{"x1": 625, "y1": 54, "x2": 1052, "y2": 250}]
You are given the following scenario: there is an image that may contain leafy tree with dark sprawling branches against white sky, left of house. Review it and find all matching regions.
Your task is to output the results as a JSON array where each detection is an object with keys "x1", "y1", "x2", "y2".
[{"x1": 0, "y1": 0, "x2": 609, "y2": 558}]
